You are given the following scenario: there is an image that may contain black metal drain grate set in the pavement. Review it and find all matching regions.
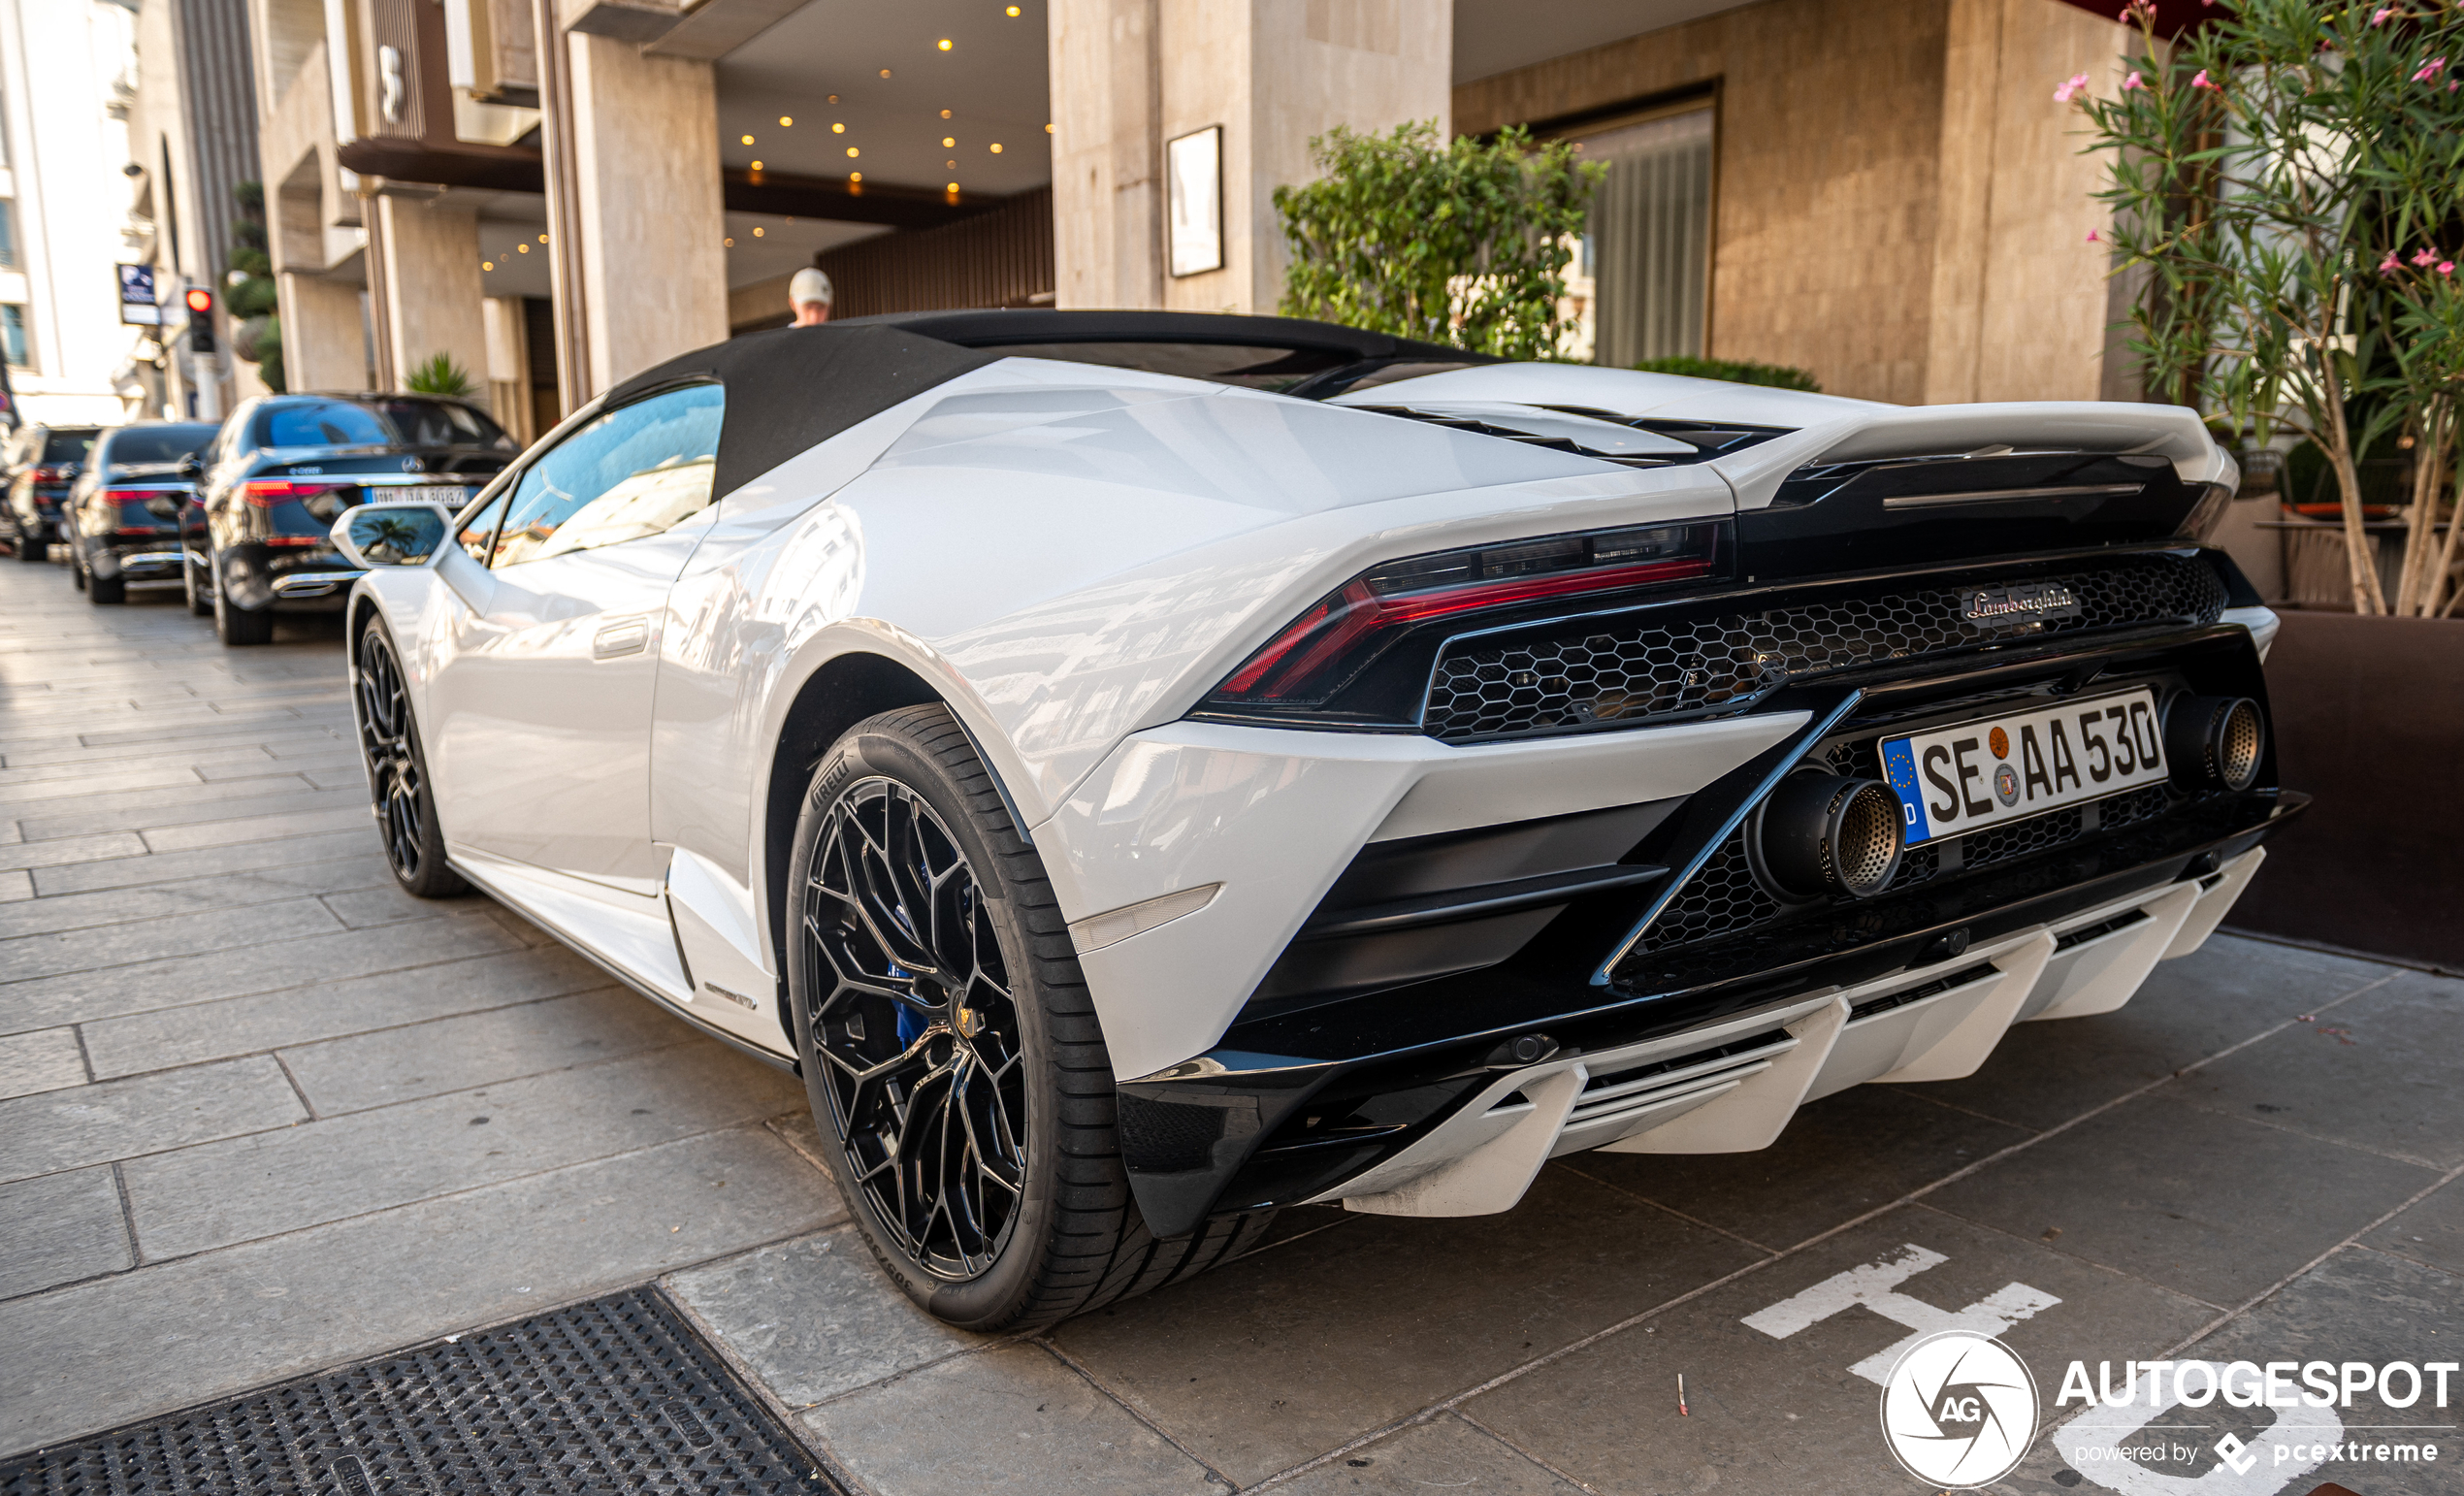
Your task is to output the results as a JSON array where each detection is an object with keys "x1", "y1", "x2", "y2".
[{"x1": 0, "y1": 1289, "x2": 835, "y2": 1496}]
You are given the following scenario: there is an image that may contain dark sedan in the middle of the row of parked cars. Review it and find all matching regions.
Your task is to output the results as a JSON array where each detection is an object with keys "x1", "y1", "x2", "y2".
[{"x1": 59, "y1": 421, "x2": 217, "y2": 603}]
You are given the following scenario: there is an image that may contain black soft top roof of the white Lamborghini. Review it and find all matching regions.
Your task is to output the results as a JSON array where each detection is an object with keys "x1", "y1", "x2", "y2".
[{"x1": 608, "y1": 309, "x2": 1496, "y2": 504}]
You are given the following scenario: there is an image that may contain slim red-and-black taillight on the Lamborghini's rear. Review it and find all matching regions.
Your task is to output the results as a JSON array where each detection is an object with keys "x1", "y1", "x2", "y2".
[{"x1": 1208, "y1": 523, "x2": 1720, "y2": 707}]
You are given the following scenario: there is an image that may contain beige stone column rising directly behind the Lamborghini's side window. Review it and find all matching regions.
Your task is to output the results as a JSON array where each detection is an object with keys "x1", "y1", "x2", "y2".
[{"x1": 565, "y1": 32, "x2": 727, "y2": 394}]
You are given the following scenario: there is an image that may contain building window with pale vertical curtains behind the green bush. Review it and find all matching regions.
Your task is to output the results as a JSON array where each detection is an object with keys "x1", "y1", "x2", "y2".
[{"x1": 1567, "y1": 106, "x2": 1712, "y2": 370}]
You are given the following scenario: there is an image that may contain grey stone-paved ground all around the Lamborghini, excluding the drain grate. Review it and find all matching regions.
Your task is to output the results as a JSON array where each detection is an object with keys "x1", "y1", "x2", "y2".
[{"x1": 0, "y1": 562, "x2": 2464, "y2": 1496}]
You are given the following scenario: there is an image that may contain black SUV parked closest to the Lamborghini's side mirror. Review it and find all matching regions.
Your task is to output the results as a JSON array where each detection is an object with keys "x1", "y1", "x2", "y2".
[{"x1": 190, "y1": 394, "x2": 520, "y2": 643}]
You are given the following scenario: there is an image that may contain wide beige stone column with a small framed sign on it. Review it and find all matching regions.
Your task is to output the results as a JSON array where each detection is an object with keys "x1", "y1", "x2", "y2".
[{"x1": 1050, "y1": 0, "x2": 1454, "y2": 313}]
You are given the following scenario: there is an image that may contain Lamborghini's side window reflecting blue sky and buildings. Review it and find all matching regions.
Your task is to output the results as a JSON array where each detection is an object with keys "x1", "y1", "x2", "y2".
[{"x1": 496, "y1": 384, "x2": 727, "y2": 567}]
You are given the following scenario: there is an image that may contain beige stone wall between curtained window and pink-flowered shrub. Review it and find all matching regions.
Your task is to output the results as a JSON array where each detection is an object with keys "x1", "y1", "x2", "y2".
[{"x1": 1454, "y1": 0, "x2": 2122, "y2": 402}]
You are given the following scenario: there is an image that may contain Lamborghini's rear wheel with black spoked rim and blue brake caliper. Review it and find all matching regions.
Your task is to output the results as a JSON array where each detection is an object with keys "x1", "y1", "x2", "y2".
[{"x1": 786, "y1": 705, "x2": 1272, "y2": 1331}]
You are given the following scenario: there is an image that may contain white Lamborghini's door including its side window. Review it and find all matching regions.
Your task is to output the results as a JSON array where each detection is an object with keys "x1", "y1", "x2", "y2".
[{"x1": 429, "y1": 384, "x2": 725, "y2": 894}]
